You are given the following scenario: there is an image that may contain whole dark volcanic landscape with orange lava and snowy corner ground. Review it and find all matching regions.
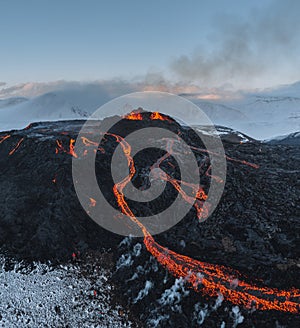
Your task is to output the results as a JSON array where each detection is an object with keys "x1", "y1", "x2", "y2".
[{"x1": 0, "y1": 110, "x2": 300, "y2": 328}]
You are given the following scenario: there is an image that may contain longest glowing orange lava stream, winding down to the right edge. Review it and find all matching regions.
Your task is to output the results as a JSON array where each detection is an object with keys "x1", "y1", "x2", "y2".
[{"x1": 113, "y1": 135, "x2": 300, "y2": 313}]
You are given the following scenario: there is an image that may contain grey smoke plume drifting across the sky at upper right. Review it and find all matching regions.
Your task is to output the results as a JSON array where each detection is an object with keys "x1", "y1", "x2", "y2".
[{"x1": 171, "y1": 0, "x2": 300, "y2": 86}]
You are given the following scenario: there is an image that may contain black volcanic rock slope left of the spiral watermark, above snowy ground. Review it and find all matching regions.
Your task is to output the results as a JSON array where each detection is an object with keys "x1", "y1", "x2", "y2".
[{"x1": 0, "y1": 121, "x2": 120, "y2": 260}]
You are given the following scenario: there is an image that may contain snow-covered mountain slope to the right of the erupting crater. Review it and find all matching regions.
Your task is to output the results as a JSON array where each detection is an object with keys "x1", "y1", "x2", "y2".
[{"x1": 191, "y1": 82, "x2": 300, "y2": 140}]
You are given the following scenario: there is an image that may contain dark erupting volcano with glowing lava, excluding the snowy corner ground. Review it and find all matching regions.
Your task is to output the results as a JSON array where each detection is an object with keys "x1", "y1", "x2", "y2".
[{"x1": 0, "y1": 111, "x2": 300, "y2": 327}]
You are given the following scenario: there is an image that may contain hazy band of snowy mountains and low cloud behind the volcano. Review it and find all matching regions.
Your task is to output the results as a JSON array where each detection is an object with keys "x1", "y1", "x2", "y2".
[{"x1": 0, "y1": 81, "x2": 300, "y2": 139}]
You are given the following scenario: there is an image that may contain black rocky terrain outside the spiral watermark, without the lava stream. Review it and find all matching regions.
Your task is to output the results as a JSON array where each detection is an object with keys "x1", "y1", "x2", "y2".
[{"x1": 0, "y1": 114, "x2": 300, "y2": 327}]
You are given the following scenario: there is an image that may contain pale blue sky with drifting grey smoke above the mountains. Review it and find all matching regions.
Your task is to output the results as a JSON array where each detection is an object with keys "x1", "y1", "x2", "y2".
[{"x1": 0, "y1": 0, "x2": 300, "y2": 89}]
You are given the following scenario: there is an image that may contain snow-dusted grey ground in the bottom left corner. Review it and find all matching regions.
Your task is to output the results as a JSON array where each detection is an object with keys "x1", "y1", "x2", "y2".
[{"x1": 0, "y1": 256, "x2": 131, "y2": 328}]
